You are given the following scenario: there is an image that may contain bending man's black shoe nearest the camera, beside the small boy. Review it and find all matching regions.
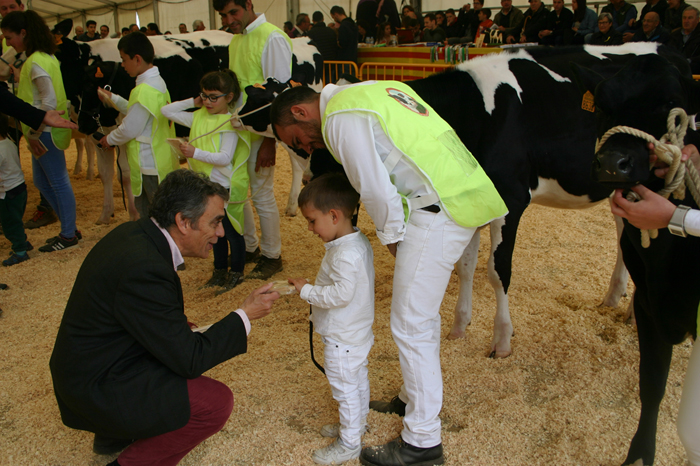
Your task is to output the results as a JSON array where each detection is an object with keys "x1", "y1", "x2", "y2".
[{"x1": 360, "y1": 435, "x2": 445, "y2": 466}]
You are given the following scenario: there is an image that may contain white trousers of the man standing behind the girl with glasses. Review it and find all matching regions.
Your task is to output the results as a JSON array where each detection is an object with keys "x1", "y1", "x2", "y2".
[{"x1": 243, "y1": 138, "x2": 282, "y2": 259}]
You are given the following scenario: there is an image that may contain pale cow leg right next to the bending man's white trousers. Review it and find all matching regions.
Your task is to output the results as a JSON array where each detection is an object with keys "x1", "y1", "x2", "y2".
[{"x1": 447, "y1": 229, "x2": 481, "y2": 340}]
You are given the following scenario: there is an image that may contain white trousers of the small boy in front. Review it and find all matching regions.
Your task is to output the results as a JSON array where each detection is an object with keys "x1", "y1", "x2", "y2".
[{"x1": 323, "y1": 337, "x2": 374, "y2": 448}]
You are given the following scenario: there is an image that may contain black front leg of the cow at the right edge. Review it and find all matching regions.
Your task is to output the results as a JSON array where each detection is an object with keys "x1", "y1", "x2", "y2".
[{"x1": 623, "y1": 290, "x2": 673, "y2": 465}]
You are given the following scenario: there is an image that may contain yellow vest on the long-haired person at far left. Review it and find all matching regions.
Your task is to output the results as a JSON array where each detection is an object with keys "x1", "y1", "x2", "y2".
[{"x1": 17, "y1": 52, "x2": 71, "y2": 150}]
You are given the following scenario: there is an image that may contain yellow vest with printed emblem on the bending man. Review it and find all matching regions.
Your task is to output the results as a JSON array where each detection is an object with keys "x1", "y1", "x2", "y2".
[{"x1": 322, "y1": 81, "x2": 508, "y2": 228}]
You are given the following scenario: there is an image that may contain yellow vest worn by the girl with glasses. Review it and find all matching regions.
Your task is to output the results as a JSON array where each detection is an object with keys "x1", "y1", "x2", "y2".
[{"x1": 187, "y1": 108, "x2": 250, "y2": 234}]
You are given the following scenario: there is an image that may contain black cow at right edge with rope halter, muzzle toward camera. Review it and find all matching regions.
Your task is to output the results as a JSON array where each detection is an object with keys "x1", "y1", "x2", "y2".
[{"x1": 579, "y1": 55, "x2": 700, "y2": 465}]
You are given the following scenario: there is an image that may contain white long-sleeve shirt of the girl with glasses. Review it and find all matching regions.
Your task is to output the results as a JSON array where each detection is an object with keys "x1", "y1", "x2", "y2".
[{"x1": 160, "y1": 98, "x2": 238, "y2": 188}]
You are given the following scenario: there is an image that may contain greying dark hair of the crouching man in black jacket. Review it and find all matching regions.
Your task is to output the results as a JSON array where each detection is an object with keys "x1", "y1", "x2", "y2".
[{"x1": 150, "y1": 170, "x2": 229, "y2": 230}]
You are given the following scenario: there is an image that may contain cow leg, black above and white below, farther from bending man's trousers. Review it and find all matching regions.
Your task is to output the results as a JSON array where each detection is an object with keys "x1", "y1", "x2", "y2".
[{"x1": 487, "y1": 217, "x2": 520, "y2": 358}]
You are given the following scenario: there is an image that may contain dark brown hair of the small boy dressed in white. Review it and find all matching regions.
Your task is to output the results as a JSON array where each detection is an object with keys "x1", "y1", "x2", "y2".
[{"x1": 299, "y1": 173, "x2": 360, "y2": 218}]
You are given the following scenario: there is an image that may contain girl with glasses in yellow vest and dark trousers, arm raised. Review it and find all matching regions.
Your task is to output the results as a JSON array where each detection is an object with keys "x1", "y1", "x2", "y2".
[{"x1": 161, "y1": 70, "x2": 250, "y2": 294}]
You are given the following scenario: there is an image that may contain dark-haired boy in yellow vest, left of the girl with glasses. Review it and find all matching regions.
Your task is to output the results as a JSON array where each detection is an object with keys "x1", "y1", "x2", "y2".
[{"x1": 98, "y1": 32, "x2": 180, "y2": 217}]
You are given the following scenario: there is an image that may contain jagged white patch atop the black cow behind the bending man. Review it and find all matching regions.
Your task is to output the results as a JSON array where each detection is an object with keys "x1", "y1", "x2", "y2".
[{"x1": 457, "y1": 49, "x2": 571, "y2": 115}]
